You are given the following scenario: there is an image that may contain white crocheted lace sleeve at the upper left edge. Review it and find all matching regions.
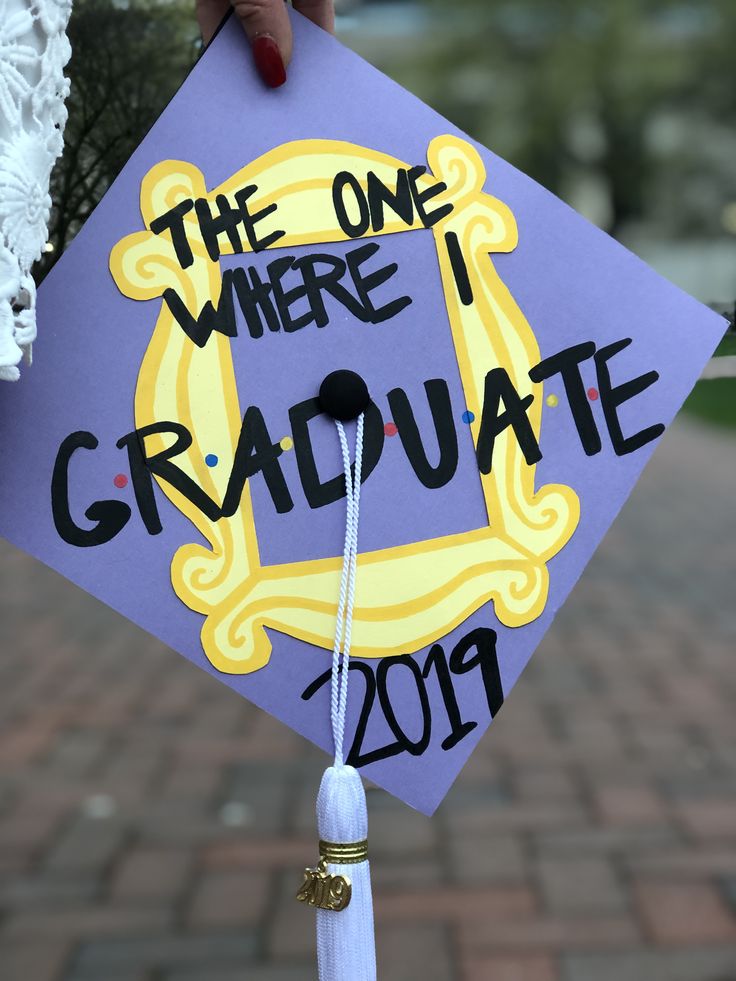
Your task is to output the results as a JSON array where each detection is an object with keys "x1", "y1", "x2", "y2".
[{"x1": 0, "y1": 0, "x2": 72, "y2": 381}]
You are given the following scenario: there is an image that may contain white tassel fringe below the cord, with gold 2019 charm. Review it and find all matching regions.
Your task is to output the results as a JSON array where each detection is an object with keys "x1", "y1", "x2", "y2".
[{"x1": 317, "y1": 766, "x2": 376, "y2": 981}]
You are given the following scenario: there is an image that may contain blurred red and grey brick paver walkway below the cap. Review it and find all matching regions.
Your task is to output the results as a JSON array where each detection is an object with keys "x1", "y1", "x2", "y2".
[{"x1": 0, "y1": 423, "x2": 736, "y2": 981}]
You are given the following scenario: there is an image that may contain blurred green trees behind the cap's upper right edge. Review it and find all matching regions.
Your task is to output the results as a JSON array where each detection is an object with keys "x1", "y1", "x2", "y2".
[{"x1": 370, "y1": 0, "x2": 736, "y2": 236}]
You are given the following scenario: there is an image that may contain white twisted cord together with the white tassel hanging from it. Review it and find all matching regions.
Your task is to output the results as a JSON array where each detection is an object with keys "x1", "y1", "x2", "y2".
[{"x1": 317, "y1": 415, "x2": 376, "y2": 981}]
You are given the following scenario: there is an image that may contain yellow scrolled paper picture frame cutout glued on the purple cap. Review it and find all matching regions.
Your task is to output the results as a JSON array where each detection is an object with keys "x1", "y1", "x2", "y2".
[{"x1": 110, "y1": 136, "x2": 580, "y2": 674}]
